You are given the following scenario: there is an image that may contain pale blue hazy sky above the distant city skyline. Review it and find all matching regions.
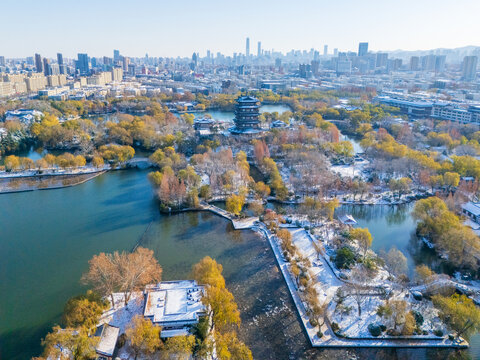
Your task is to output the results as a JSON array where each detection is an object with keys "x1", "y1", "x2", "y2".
[{"x1": 0, "y1": 0, "x2": 480, "y2": 57}]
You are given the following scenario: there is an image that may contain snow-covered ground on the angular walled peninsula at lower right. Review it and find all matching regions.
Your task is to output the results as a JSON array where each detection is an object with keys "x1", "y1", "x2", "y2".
[{"x1": 270, "y1": 227, "x2": 466, "y2": 347}]
